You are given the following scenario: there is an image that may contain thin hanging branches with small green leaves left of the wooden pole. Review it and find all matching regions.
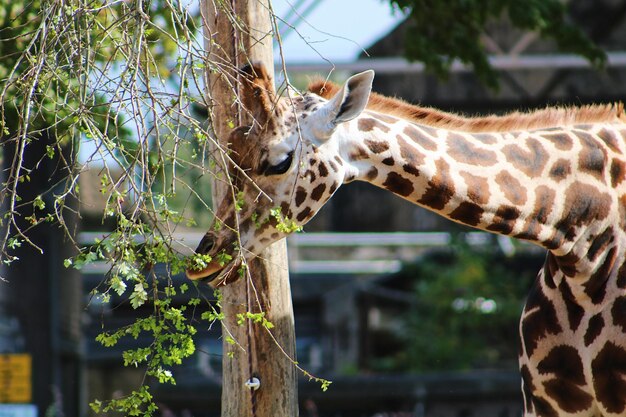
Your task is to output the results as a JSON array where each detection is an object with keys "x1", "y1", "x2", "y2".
[{"x1": 0, "y1": 0, "x2": 216, "y2": 415}]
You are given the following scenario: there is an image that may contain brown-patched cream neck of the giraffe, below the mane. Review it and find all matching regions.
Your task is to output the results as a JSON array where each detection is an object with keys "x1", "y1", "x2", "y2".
[{"x1": 341, "y1": 112, "x2": 626, "y2": 290}]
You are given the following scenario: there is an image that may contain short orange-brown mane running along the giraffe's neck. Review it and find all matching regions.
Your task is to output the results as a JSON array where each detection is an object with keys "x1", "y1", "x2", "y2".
[{"x1": 307, "y1": 80, "x2": 626, "y2": 133}]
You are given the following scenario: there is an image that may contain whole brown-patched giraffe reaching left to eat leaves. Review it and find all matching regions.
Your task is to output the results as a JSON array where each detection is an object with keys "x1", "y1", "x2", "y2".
[{"x1": 187, "y1": 62, "x2": 626, "y2": 417}]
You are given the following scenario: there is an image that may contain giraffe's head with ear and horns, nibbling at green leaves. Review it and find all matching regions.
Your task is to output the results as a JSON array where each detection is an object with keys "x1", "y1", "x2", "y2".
[{"x1": 187, "y1": 65, "x2": 374, "y2": 286}]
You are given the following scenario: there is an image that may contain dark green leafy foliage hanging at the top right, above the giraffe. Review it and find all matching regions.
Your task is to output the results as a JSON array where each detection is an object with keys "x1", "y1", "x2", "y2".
[{"x1": 389, "y1": 0, "x2": 606, "y2": 87}]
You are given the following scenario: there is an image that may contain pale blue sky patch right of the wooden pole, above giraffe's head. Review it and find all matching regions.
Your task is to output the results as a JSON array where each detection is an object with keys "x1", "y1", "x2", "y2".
[{"x1": 272, "y1": 0, "x2": 402, "y2": 62}]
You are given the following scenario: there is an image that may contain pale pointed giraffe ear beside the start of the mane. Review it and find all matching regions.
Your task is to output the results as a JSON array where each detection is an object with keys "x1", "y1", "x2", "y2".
[{"x1": 324, "y1": 70, "x2": 374, "y2": 126}]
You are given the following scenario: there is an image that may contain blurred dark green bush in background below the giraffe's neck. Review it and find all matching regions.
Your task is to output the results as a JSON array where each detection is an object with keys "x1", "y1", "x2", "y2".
[{"x1": 401, "y1": 246, "x2": 540, "y2": 371}]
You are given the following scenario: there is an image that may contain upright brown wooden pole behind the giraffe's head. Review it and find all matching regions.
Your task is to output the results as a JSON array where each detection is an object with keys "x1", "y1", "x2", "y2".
[{"x1": 202, "y1": 0, "x2": 298, "y2": 417}]
